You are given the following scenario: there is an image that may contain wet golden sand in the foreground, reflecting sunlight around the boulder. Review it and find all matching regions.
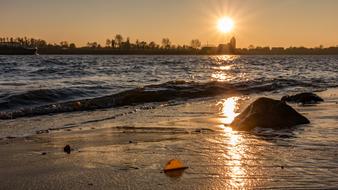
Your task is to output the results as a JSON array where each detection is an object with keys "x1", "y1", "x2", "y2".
[{"x1": 0, "y1": 89, "x2": 338, "y2": 189}]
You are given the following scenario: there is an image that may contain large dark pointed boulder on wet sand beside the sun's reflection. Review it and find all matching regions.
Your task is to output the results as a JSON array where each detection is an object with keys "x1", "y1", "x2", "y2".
[{"x1": 230, "y1": 98, "x2": 310, "y2": 131}]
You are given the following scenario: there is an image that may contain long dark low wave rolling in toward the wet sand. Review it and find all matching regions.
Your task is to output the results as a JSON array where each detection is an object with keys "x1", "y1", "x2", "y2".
[{"x1": 0, "y1": 79, "x2": 330, "y2": 119}]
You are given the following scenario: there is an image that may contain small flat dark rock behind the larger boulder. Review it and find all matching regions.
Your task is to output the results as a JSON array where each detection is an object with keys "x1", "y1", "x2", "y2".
[{"x1": 281, "y1": 93, "x2": 324, "y2": 104}]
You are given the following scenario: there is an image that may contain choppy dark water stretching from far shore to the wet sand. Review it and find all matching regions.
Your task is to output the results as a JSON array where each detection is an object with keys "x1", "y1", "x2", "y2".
[{"x1": 0, "y1": 56, "x2": 338, "y2": 115}]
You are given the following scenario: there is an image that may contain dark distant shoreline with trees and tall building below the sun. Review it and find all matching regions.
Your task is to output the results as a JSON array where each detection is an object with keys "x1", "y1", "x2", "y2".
[{"x1": 0, "y1": 34, "x2": 338, "y2": 55}]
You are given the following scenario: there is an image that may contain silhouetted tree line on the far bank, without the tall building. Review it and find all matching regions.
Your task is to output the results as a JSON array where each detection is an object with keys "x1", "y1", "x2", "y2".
[{"x1": 0, "y1": 34, "x2": 338, "y2": 55}]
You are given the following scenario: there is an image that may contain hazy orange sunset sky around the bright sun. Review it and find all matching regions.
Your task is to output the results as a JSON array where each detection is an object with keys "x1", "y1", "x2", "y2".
[{"x1": 0, "y1": 0, "x2": 338, "y2": 48}]
